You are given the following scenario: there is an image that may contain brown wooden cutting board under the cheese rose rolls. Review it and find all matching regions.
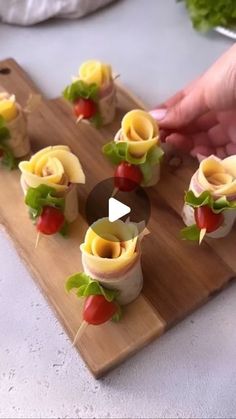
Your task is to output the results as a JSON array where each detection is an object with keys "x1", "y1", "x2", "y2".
[{"x1": 0, "y1": 59, "x2": 236, "y2": 377}]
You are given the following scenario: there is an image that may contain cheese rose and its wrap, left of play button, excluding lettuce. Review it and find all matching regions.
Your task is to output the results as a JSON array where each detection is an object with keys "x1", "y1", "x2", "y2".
[{"x1": 19, "y1": 145, "x2": 85, "y2": 222}]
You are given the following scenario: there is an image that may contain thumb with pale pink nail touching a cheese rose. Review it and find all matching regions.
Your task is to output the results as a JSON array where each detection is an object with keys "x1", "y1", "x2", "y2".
[{"x1": 150, "y1": 86, "x2": 209, "y2": 129}]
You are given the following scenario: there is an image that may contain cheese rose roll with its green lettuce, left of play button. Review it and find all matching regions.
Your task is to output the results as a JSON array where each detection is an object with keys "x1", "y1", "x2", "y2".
[{"x1": 19, "y1": 145, "x2": 85, "y2": 234}]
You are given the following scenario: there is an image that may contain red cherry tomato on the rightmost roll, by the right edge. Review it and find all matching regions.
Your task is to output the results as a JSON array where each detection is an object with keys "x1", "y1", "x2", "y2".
[{"x1": 194, "y1": 205, "x2": 224, "y2": 233}]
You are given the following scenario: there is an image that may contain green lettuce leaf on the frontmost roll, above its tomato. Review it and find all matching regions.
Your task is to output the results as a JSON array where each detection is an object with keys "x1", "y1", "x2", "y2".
[{"x1": 66, "y1": 272, "x2": 119, "y2": 301}]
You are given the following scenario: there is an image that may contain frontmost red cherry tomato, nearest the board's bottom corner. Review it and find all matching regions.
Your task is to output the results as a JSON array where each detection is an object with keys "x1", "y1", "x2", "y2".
[{"x1": 83, "y1": 295, "x2": 117, "y2": 325}]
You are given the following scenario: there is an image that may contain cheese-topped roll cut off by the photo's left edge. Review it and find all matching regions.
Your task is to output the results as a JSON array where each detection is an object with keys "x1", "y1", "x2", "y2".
[{"x1": 0, "y1": 92, "x2": 30, "y2": 167}]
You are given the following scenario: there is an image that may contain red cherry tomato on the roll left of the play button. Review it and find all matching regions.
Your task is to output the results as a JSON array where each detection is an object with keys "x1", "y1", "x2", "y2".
[{"x1": 37, "y1": 206, "x2": 65, "y2": 235}]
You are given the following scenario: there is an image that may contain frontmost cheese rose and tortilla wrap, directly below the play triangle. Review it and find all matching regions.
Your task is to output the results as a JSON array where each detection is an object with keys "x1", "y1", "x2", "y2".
[{"x1": 80, "y1": 218, "x2": 143, "y2": 304}]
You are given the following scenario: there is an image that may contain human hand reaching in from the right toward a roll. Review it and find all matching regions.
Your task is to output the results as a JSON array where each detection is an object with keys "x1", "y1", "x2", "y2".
[{"x1": 150, "y1": 44, "x2": 236, "y2": 159}]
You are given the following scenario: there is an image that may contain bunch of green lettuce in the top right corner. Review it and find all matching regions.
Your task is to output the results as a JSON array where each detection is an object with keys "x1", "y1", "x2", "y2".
[{"x1": 178, "y1": 0, "x2": 236, "y2": 32}]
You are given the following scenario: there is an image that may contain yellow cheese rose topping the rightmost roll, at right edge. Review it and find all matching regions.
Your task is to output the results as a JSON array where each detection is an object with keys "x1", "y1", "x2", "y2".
[{"x1": 197, "y1": 156, "x2": 236, "y2": 196}]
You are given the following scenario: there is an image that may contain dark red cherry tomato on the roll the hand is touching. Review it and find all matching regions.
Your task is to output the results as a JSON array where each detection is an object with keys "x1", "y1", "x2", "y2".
[{"x1": 114, "y1": 162, "x2": 143, "y2": 192}]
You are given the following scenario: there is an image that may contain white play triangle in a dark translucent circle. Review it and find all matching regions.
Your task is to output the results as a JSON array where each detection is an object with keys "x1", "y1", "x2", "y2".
[{"x1": 85, "y1": 178, "x2": 151, "y2": 241}]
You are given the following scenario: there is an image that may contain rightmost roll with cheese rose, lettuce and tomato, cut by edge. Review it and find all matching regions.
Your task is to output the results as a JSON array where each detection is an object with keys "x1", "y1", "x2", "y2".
[{"x1": 182, "y1": 156, "x2": 236, "y2": 241}]
